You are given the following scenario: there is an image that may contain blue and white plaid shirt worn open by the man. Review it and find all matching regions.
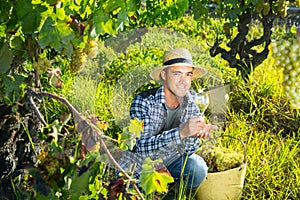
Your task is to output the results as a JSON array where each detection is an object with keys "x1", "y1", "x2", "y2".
[{"x1": 119, "y1": 86, "x2": 200, "y2": 174}]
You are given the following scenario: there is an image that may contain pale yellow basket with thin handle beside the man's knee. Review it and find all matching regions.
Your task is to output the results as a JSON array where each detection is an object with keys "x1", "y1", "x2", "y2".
[{"x1": 196, "y1": 136, "x2": 247, "y2": 200}]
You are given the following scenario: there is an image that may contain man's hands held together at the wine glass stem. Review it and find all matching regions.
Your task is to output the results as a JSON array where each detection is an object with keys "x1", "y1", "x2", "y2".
[{"x1": 180, "y1": 116, "x2": 218, "y2": 139}]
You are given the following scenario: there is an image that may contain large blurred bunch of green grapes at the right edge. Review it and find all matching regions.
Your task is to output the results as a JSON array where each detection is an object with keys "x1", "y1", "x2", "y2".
[{"x1": 271, "y1": 40, "x2": 300, "y2": 109}]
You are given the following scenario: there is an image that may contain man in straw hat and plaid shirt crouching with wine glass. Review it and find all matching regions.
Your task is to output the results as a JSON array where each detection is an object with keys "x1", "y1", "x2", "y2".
[{"x1": 120, "y1": 48, "x2": 216, "y2": 194}]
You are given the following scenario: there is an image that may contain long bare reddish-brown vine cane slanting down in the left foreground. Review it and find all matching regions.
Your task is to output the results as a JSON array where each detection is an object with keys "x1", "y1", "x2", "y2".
[{"x1": 27, "y1": 89, "x2": 144, "y2": 200}]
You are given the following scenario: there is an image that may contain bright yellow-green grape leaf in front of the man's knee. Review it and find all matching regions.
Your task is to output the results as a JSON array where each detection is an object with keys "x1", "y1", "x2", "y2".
[{"x1": 139, "y1": 158, "x2": 174, "y2": 194}]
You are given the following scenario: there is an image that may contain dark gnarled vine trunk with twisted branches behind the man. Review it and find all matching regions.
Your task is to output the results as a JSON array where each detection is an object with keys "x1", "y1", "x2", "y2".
[{"x1": 210, "y1": 9, "x2": 276, "y2": 81}]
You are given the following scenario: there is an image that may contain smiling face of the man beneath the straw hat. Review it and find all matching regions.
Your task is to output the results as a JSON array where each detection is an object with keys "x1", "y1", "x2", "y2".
[{"x1": 161, "y1": 66, "x2": 193, "y2": 98}]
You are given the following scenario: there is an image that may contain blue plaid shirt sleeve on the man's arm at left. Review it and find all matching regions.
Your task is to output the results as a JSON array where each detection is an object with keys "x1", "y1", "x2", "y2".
[{"x1": 130, "y1": 95, "x2": 182, "y2": 157}]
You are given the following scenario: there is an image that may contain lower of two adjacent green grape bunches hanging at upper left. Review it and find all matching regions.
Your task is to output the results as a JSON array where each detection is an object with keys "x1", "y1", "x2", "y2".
[{"x1": 70, "y1": 48, "x2": 87, "y2": 73}]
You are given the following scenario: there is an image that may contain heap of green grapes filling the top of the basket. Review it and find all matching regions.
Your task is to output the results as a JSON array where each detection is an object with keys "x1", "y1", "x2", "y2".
[{"x1": 199, "y1": 146, "x2": 244, "y2": 172}]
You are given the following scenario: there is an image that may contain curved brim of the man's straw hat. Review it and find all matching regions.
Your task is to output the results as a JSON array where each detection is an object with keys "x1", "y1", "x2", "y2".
[{"x1": 150, "y1": 63, "x2": 207, "y2": 81}]
